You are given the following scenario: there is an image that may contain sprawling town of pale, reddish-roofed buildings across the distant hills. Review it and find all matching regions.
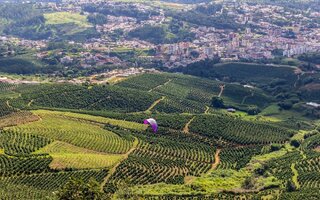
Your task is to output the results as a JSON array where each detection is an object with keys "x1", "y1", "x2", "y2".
[{"x1": 0, "y1": 0, "x2": 320, "y2": 68}]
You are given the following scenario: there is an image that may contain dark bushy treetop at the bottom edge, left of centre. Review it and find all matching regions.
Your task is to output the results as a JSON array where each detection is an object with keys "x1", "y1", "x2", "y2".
[{"x1": 57, "y1": 178, "x2": 104, "y2": 200}]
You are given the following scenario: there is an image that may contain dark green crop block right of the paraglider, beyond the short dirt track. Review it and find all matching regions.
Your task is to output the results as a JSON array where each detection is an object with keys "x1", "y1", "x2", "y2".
[{"x1": 190, "y1": 115, "x2": 295, "y2": 145}]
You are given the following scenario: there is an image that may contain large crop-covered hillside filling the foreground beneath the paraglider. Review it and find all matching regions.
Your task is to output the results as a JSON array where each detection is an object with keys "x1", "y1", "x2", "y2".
[{"x1": 0, "y1": 73, "x2": 320, "y2": 199}]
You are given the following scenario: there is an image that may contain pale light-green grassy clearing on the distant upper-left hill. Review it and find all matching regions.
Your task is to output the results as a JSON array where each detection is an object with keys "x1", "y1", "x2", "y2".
[{"x1": 44, "y1": 12, "x2": 91, "y2": 27}]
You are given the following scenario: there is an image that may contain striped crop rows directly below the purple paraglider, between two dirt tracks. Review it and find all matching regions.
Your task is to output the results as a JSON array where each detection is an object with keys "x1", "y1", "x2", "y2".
[{"x1": 104, "y1": 128, "x2": 215, "y2": 193}]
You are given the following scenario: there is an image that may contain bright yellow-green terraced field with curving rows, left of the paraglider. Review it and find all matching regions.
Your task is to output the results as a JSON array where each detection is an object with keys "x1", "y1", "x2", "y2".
[{"x1": 0, "y1": 110, "x2": 138, "y2": 199}]
